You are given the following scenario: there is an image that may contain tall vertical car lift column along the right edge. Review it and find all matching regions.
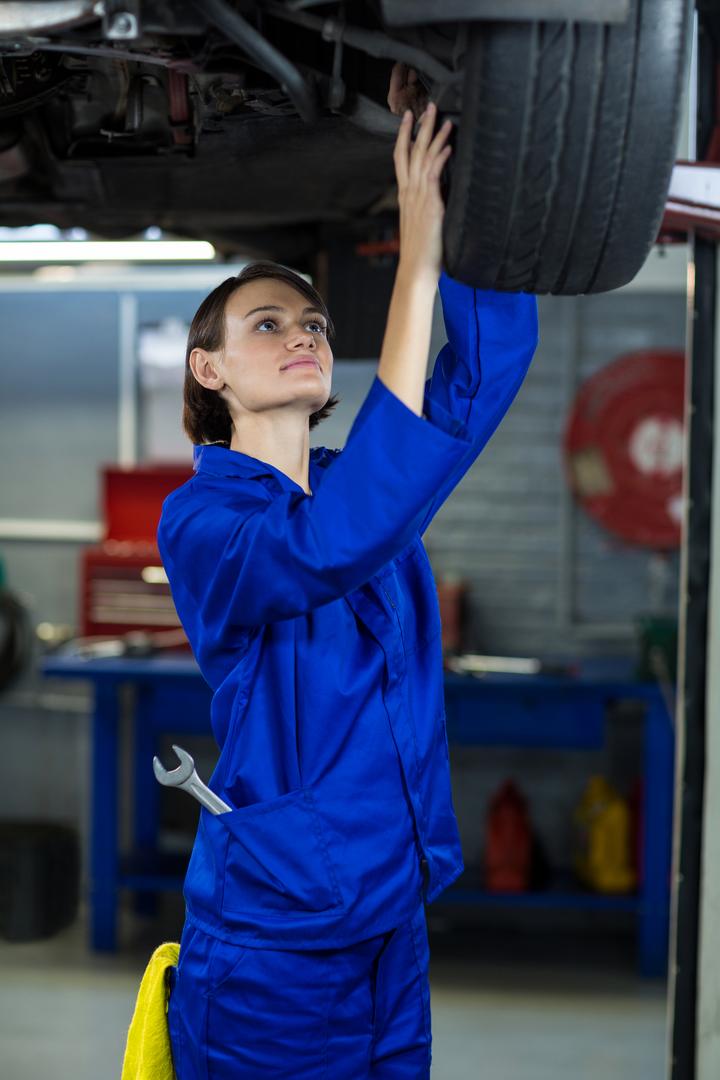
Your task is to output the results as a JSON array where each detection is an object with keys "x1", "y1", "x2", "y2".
[{"x1": 665, "y1": 0, "x2": 720, "y2": 1080}]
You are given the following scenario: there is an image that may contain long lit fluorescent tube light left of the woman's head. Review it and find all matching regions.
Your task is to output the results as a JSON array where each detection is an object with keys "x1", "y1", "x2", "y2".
[{"x1": 0, "y1": 240, "x2": 215, "y2": 262}]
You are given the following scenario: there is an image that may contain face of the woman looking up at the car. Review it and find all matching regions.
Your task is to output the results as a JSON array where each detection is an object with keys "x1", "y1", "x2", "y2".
[{"x1": 212, "y1": 278, "x2": 332, "y2": 419}]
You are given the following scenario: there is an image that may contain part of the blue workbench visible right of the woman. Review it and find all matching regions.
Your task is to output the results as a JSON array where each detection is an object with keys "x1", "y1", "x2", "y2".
[{"x1": 437, "y1": 661, "x2": 675, "y2": 976}]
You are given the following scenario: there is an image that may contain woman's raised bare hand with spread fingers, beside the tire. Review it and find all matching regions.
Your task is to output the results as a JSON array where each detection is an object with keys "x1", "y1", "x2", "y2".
[{"x1": 393, "y1": 102, "x2": 452, "y2": 283}]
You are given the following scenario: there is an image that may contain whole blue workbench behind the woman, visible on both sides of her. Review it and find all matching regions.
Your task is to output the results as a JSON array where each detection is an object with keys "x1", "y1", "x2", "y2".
[{"x1": 42, "y1": 653, "x2": 675, "y2": 976}]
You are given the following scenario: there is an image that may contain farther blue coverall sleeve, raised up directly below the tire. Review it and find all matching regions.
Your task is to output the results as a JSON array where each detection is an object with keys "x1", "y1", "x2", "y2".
[{"x1": 419, "y1": 272, "x2": 538, "y2": 534}]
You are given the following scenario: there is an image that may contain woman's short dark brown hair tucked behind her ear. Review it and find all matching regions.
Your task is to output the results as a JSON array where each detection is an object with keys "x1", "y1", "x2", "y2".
[{"x1": 182, "y1": 261, "x2": 340, "y2": 446}]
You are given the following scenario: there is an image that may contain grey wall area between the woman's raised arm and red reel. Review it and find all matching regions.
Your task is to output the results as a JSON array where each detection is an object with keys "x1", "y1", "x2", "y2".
[{"x1": 425, "y1": 293, "x2": 684, "y2": 654}]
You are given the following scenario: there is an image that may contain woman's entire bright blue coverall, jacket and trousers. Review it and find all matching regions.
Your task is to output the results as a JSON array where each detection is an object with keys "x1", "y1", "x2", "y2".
[{"x1": 158, "y1": 273, "x2": 538, "y2": 1080}]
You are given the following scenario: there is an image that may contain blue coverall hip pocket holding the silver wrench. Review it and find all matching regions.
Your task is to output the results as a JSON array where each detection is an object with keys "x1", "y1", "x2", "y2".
[{"x1": 215, "y1": 787, "x2": 343, "y2": 917}]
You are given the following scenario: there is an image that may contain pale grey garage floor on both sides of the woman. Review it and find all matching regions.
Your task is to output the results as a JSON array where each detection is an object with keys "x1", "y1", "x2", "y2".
[{"x1": 0, "y1": 912, "x2": 666, "y2": 1080}]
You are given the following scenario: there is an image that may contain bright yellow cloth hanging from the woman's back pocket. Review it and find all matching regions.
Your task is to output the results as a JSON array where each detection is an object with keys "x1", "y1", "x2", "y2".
[{"x1": 121, "y1": 942, "x2": 180, "y2": 1080}]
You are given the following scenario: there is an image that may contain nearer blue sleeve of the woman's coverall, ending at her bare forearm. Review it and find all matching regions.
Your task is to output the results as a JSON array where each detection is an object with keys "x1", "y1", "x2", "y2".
[{"x1": 157, "y1": 375, "x2": 481, "y2": 630}]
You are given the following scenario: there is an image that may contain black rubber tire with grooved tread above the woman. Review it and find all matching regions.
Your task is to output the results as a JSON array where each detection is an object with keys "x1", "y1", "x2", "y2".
[{"x1": 444, "y1": 0, "x2": 692, "y2": 296}]
